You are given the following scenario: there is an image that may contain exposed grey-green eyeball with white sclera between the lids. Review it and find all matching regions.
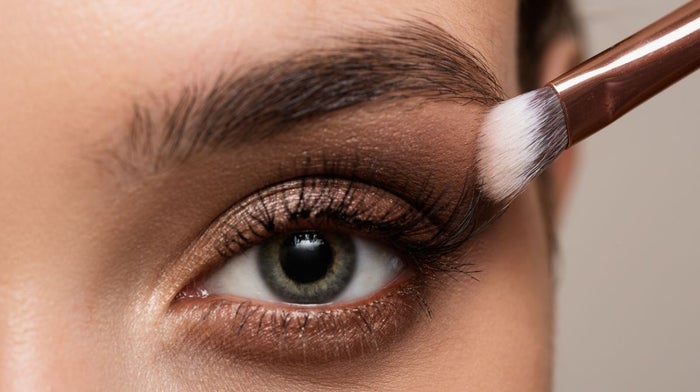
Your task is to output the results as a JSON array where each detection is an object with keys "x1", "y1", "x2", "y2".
[{"x1": 202, "y1": 230, "x2": 404, "y2": 305}]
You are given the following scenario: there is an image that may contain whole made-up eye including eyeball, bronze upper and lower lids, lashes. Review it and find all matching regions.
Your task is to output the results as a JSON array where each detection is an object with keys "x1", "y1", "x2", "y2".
[{"x1": 165, "y1": 177, "x2": 492, "y2": 361}]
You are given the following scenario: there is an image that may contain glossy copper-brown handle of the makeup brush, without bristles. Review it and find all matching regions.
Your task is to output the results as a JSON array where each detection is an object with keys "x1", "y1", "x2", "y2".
[{"x1": 549, "y1": 0, "x2": 700, "y2": 146}]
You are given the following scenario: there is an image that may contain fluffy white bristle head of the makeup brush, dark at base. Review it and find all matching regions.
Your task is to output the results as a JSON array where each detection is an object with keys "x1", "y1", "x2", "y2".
[{"x1": 477, "y1": 87, "x2": 568, "y2": 202}]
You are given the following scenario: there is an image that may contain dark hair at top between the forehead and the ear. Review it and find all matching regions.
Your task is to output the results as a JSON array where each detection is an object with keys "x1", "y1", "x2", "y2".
[{"x1": 518, "y1": 0, "x2": 579, "y2": 91}]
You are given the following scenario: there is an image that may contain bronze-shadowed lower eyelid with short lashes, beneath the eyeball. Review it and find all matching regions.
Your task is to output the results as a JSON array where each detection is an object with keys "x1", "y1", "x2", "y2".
[{"x1": 171, "y1": 280, "x2": 430, "y2": 364}]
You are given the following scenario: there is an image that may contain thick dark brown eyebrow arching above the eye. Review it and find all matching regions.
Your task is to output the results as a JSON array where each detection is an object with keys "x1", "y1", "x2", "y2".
[{"x1": 110, "y1": 19, "x2": 505, "y2": 173}]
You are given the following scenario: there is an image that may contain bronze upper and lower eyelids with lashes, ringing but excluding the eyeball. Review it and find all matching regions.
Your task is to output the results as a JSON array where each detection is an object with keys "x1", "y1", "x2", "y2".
[{"x1": 166, "y1": 167, "x2": 492, "y2": 361}]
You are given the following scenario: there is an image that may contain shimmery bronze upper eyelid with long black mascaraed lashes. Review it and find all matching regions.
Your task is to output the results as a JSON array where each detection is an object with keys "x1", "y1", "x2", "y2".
[{"x1": 212, "y1": 177, "x2": 486, "y2": 274}]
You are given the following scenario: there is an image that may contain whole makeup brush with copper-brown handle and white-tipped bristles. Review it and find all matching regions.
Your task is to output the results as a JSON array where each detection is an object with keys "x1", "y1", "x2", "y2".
[{"x1": 477, "y1": 0, "x2": 700, "y2": 203}]
